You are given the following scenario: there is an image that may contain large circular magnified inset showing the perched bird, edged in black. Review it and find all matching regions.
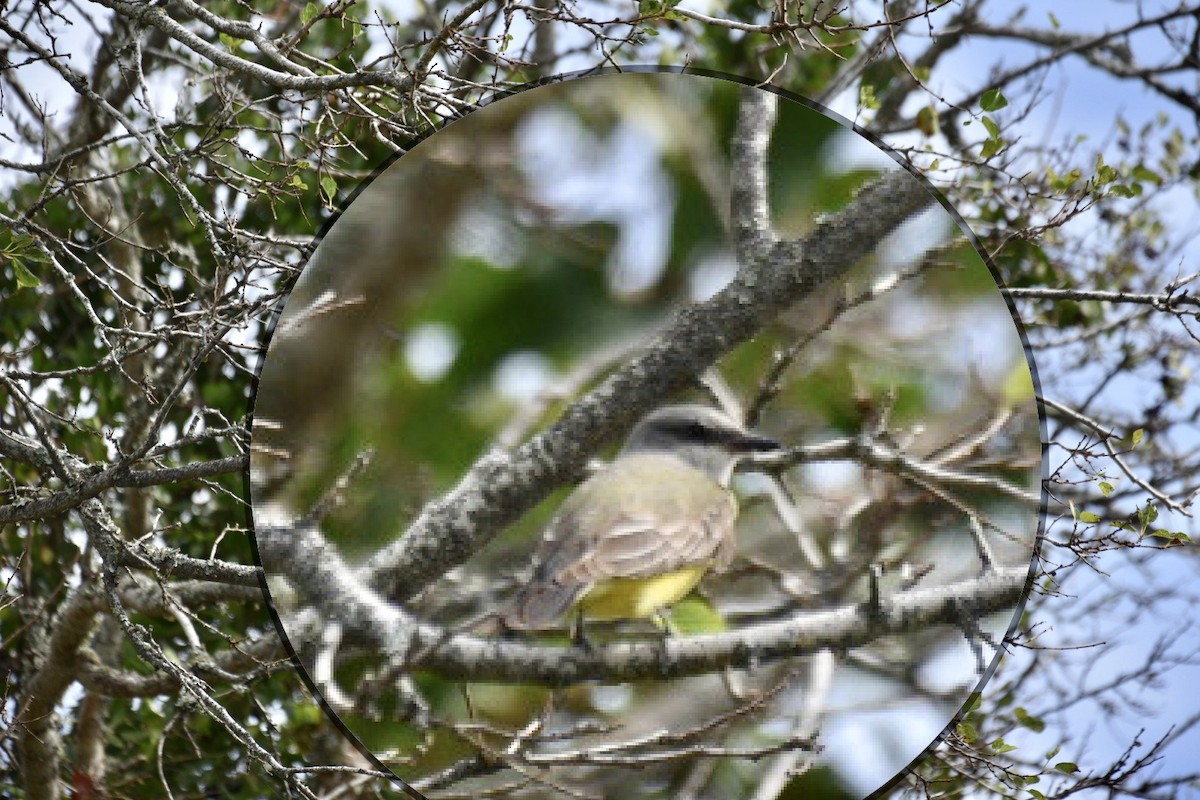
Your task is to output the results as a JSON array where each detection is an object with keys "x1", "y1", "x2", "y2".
[{"x1": 252, "y1": 73, "x2": 1043, "y2": 800}]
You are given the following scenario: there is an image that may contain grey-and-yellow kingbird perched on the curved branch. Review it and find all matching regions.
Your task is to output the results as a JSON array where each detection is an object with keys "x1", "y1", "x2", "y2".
[{"x1": 502, "y1": 405, "x2": 779, "y2": 628}]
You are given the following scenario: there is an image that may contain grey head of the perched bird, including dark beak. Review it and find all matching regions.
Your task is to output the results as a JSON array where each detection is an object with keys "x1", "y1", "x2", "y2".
[{"x1": 618, "y1": 405, "x2": 780, "y2": 486}]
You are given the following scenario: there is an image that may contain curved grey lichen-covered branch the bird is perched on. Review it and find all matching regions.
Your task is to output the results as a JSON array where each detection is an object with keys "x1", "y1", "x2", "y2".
[{"x1": 258, "y1": 525, "x2": 1028, "y2": 685}]
